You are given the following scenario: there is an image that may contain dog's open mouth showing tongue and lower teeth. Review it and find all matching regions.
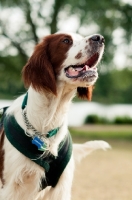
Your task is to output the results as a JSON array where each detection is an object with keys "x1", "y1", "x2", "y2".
[{"x1": 64, "y1": 53, "x2": 99, "y2": 78}]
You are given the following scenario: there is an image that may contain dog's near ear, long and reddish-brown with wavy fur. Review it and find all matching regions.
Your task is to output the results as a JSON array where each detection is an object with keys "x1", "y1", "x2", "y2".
[{"x1": 22, "y1": 38, "x2": 57, "y2": 95}]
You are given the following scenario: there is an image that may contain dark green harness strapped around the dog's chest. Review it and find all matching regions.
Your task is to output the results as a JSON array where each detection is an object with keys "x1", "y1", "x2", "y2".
[{"x1": 0, "y1": 95, "x2": 72, "y2": 190}]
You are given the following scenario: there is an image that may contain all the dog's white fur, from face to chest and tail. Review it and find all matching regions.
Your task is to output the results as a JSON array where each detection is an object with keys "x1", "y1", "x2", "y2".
[{"x1": 0, "y1": 34, "x2": 109, "y2": 200}]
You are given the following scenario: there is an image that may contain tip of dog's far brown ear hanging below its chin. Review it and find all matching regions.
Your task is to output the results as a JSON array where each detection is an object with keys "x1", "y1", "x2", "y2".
[{"x1": 77, "y1": 85, "x2": 94, "y2": 101}]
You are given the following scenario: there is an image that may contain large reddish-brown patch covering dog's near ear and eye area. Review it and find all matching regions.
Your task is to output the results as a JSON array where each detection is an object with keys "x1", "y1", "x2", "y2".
[{"x1": 22, "y1": 34, "x2": 72, "y2": 95}]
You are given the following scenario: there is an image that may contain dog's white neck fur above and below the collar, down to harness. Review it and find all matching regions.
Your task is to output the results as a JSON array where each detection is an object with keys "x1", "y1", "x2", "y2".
[{"x1": 7, "y1": 83, "x2": 76, "y2": 156}]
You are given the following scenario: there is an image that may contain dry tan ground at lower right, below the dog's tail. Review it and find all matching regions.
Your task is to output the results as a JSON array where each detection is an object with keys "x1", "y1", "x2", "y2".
[{"x1": 72, "y1": 144, "x2": 132, "y2": 200}]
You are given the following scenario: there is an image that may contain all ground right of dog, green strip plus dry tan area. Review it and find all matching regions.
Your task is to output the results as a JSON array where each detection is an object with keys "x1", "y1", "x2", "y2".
[{"x1": 70, "y1": 125, "x2": 132, "y2": 200}]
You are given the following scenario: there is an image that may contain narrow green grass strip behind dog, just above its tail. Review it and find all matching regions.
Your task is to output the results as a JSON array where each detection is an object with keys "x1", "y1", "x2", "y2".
[{"x1": 69, "y1": 125, "x2": 132, "y2": 141}]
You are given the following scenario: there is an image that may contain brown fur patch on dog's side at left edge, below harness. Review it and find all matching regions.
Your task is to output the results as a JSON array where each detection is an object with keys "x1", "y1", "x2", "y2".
[{"x1": 0, "y1": 128, "x2": 5, "y2": 184}]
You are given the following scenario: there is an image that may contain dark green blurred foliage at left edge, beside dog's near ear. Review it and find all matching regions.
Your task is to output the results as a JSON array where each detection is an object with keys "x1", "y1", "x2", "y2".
[{"x1": 0, "y1": 55, "x2": 25, "y2": 99}]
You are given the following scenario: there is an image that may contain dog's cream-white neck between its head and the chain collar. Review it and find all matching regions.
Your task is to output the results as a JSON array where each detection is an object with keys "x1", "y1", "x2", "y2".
[{"x1": 27, "y1": 83, "x2": 76, "y2": 132}]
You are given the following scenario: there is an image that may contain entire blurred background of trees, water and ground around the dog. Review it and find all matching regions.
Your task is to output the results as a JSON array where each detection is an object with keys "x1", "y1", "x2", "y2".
[{"x1": 0, "y1": 0, "x2": 132, "y2": 200}]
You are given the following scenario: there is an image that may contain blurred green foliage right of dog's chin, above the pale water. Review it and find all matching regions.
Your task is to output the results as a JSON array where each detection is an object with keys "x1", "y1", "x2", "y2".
[{"x1": 93, "y1": 69, "x2": 132, "y2": 104}]
